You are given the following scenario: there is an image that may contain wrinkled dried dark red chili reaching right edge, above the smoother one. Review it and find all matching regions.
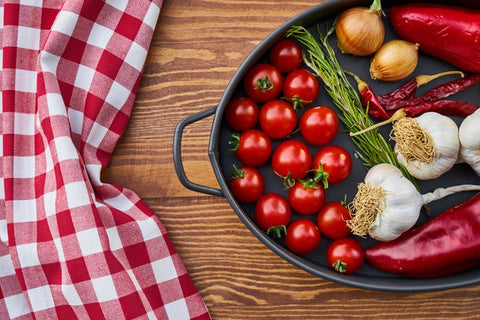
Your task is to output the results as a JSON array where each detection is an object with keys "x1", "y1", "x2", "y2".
[{"x1": 382, "y1": 73, "x2": 480, "y2": 110}]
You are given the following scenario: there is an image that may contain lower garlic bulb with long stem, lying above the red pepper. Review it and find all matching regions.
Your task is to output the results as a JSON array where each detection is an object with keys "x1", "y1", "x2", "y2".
[{"x1": 347, "y1": 163, "x2": 480, "y2": 241}]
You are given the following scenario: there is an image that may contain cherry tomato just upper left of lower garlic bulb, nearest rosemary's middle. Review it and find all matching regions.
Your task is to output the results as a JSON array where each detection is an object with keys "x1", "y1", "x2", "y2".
[{"x1": 313, "y1": 145, "x2": 352, "y2": 184}]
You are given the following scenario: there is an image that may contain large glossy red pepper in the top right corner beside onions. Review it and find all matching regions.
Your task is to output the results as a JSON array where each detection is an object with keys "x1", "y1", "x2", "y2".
[{"x1": 389, "y1": 3, "x2": 480, "y2": 72}]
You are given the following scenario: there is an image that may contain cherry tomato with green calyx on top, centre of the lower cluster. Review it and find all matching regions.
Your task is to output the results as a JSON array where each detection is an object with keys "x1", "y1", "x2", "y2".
[{"x1": 288, "y1": 180, "x2": 325, "y2": 215}]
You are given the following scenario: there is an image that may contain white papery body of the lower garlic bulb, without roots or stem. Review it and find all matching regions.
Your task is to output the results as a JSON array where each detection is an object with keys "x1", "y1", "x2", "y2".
[{"x1": 365, "y1": 163, "x2": 423, "y2": 241}]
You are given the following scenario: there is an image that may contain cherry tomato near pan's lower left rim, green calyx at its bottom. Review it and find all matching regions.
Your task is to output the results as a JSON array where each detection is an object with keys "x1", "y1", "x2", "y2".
[{"x1": 255, "y1": 192, "x2": 292, "y2": 237}]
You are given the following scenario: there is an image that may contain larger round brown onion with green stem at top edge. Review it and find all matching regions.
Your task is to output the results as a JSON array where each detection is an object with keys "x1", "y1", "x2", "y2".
[{"x1": 335, "y1": 0, "x2": 385, "y2": 56}]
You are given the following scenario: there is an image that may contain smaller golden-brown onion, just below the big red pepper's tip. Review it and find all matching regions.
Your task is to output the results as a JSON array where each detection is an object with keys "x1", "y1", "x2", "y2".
[{"x1": 370, "y1": 39, "x2": 418, "y2": 81}]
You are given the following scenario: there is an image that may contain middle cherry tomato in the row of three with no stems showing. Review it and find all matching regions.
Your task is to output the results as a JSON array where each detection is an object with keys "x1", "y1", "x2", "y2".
[{"x1": 259, "y1": 99, "x2": 297, "y2": 139}]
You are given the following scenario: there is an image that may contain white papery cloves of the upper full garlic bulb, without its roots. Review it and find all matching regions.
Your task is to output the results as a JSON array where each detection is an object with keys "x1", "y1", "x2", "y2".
[{"x1": 394, "y1": 112, "x2": 460, "y2": 180}]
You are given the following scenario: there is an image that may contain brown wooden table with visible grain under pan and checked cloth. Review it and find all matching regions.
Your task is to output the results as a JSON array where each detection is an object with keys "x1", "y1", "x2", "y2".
[{"x1": 99, "y1": 0, "x2": 480, "y2": 320}]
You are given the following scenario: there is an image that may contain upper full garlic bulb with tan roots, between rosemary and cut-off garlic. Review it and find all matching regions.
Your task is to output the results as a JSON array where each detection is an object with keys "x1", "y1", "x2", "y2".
[{"x1": 392, "y1": 112, "x2": 460, "y2": 180}]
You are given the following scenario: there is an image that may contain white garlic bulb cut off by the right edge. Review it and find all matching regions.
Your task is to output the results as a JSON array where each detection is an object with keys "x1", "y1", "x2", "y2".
[{"x1": 458, "y1": 109, "x2": 480, "y2": 176}]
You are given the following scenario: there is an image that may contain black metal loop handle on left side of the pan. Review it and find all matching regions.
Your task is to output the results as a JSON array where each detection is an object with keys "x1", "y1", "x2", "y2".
[{"x1": 173, "y1": 107, "x2": 224, "y2": 197}]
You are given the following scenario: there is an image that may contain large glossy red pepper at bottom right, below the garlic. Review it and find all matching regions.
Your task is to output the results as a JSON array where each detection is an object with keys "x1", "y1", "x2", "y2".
[{"x1": 366, "y1": 193, "x2": 480, "y2": 278}]
